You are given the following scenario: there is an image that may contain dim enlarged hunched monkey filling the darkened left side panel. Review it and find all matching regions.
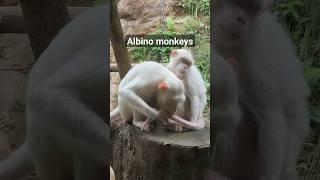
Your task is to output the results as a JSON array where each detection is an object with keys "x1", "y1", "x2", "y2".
[{"x1": 0, "y1": 6, "x2": 110, "y2": 180}]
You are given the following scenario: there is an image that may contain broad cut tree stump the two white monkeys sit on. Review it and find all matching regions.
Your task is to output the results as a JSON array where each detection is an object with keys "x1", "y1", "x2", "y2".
[{"x1": 111, "y1": 123, "x2": 210, "y2": 180}]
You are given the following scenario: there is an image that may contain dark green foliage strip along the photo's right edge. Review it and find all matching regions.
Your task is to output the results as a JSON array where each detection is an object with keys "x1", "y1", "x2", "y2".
[{"x1": 274, "y1": 0, "x2": 320, "y2": 175}]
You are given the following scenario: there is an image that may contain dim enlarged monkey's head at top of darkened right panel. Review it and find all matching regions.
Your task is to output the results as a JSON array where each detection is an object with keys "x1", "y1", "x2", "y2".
[{"x1": 214, "y1": 0, "x2": 272, "y2": 47}]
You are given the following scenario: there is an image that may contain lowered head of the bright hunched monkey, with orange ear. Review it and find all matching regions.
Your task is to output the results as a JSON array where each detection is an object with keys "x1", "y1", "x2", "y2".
[{"x1": 157, "y1": 78, "x2": 186, "y2": 114}]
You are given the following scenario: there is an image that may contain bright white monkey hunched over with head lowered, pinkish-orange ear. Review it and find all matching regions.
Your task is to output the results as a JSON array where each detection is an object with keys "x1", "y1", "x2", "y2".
[{"x1": 110, "y1": 61, "x2": 185, "y2": 131}]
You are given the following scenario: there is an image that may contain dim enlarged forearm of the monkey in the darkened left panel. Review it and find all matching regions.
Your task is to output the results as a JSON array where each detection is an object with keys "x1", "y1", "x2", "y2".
[{"x1": 27, "y1": 87, "x2": 109, "y2": 154}]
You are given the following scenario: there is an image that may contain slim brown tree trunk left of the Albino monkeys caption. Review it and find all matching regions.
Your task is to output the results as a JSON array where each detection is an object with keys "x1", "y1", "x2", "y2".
[{"x1": 110, "y1": 0, "x2": 131, "y2": 79}]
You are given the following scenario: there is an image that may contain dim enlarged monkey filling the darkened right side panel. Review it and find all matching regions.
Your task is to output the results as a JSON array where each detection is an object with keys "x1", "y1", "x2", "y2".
[{"x1": 208, "y1": 0, "x2": 309, "y2": 180}]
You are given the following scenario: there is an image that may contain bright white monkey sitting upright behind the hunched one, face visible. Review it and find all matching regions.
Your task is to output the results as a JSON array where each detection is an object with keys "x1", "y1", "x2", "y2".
[{"x1": 167, "y1": 49, "x2": 207, "y2": 130}]
